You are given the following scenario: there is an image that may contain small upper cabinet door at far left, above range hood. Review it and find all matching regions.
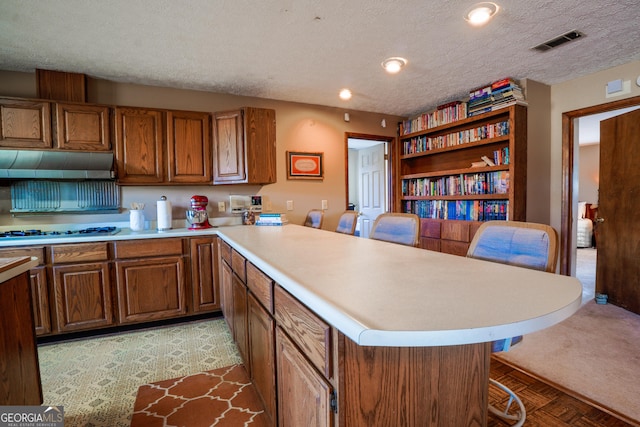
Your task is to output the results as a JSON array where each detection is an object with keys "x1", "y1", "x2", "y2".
[{"x1": 0, "y1": 98, "x2": 52, "y2": 149}]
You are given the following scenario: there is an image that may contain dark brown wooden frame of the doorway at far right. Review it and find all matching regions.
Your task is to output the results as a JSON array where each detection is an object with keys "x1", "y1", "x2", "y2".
[{"x1": 560, "y1": 96, "x2": 640, "y2": 276}]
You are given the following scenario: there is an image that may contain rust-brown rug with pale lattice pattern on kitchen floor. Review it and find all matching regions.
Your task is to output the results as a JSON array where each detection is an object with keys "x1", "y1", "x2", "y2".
[{"x1": 131, "y1": 365, "x2": 269, "y2": 427}]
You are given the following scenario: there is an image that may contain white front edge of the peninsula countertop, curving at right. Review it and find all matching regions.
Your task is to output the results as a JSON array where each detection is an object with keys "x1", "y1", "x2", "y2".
[{"x1": 218, "y1": 230, "x2": 582, "y2": 347}]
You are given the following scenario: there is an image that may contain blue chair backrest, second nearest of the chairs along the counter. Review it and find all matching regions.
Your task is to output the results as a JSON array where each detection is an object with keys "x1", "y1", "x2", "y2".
[{"x1": 369, "y1": 213, "x2": 420, "y2": 247}]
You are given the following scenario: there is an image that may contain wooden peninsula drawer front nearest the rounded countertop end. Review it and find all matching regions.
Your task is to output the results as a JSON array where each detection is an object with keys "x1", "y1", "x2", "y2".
[{"x1": 274, "y1": 286, "x2": 332, "y2": 378}]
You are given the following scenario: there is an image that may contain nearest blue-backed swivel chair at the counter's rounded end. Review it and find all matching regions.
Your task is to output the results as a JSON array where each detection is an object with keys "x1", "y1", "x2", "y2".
[{"x1": 467, "y1": 221, "x2": 558, "y2": 427}]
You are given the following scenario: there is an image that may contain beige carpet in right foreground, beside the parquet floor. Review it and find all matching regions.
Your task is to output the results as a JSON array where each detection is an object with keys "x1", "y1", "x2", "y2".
[{"x1": 497, "y1": 301, "x2": 640, "y2": 424}]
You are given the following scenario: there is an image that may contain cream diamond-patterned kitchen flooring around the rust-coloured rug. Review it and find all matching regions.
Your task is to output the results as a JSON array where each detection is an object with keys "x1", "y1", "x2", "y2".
[{"x1": 38, "y1": 319, "x2": 240, "y2": 427}]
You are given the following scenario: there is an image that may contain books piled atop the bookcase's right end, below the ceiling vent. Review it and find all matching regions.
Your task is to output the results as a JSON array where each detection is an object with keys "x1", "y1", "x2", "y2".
[{"x1": 468, "y1": 77, "x2": 526, "y2": 117}]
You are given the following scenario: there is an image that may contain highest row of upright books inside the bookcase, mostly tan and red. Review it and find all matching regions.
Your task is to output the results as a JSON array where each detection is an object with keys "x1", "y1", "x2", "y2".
[{"x1": 402, "y1": 121, "x2": 509, "y2": 154}]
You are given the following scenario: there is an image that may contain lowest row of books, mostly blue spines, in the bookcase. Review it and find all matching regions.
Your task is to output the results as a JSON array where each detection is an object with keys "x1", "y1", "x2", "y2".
[{"x1": 403, "y1": 200, "x2": 509, "y2": 221}]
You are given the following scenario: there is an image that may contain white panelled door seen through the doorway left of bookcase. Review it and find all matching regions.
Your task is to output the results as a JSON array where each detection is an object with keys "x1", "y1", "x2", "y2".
[{"x1": 358, "y1": 143, "x2": 387, "y2": 238}]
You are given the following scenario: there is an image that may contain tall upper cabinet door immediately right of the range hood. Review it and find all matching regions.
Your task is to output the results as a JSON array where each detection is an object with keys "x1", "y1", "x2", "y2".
[{"x1": 115, "y1": 108, "x2": 166, "y2": 184}]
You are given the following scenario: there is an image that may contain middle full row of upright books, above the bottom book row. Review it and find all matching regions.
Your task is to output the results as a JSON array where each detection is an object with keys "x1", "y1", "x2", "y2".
[{"x1": 402, "y1": 171, "x2": 509, "y2": 197}]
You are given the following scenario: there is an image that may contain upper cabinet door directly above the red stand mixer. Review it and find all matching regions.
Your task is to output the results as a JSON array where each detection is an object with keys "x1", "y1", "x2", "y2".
[{"x1": 167, "y1": 111, "x2": 212, "y2": 184}]
